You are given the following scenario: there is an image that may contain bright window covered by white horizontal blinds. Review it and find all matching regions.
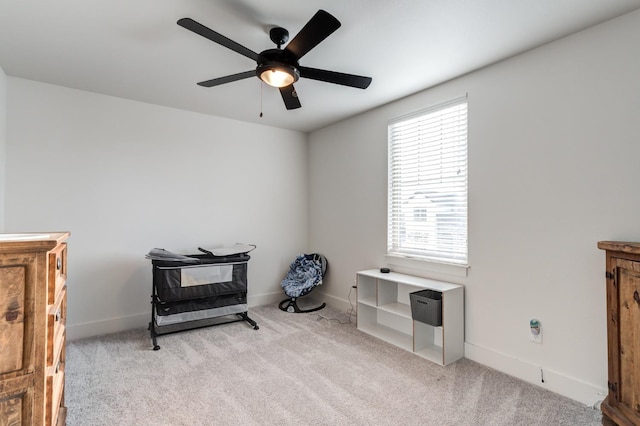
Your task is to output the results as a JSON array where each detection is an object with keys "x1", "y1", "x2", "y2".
[{"x1": 387, "y1": 97, "x2": 467, "y2": 265}]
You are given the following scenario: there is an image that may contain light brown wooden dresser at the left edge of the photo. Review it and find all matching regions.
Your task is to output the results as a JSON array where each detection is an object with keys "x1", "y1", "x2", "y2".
[{"x1": 0, "y1": 232, "x2": 69, "y2": 426}]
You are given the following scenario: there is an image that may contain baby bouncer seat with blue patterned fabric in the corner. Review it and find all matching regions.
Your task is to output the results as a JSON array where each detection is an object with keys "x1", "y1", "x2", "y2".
[{"x1": 279, "y1": 253, "x2": 327, "y2": 313}]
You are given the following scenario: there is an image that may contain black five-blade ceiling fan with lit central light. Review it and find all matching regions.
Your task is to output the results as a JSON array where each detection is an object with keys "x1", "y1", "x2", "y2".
[{"x1": 178, "y1": 10, "x2": 371, "y2": 109}]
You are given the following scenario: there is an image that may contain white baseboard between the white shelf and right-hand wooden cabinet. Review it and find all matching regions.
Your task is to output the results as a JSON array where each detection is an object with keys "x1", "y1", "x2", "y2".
[{"x1": 464, "y1": 342, "x2": 607, "y2": 408}]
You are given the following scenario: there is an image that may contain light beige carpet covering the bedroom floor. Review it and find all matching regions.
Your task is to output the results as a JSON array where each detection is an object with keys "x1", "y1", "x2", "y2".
[{"x1": 65, "y1": 306, "x2": 602, "y2": 426}]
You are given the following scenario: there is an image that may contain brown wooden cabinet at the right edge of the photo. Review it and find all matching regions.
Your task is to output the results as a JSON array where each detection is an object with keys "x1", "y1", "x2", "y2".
[{"x1": 598, "y1": 241, "x2": 640, "y2": 426}]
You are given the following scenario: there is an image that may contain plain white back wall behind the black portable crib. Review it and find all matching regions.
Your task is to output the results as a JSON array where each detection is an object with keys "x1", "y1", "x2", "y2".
[{"x1": 6, "y1": 77, "x2": 308, "y2": 339}]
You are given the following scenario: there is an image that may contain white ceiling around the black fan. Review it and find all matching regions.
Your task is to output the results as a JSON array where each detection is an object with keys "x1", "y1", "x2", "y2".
[{"x1": 0, "y1": 0, "x2": 640, "y2": 132}]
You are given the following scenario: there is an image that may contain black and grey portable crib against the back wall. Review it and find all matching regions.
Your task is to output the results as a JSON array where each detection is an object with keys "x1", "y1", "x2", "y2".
[{"x1": 149, "y1": 250, "x2": 259, "y2": 350}]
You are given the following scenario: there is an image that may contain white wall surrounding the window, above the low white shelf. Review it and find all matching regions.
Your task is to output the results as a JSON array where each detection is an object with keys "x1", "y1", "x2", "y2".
[{"x1": 309, "y1": 11, "x2": 640, "y2": 404}]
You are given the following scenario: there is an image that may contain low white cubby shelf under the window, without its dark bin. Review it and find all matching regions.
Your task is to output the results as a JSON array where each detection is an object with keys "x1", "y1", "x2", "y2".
[{"x1": 356, "y1": 269, "x2": 464, "y2": 365}]
